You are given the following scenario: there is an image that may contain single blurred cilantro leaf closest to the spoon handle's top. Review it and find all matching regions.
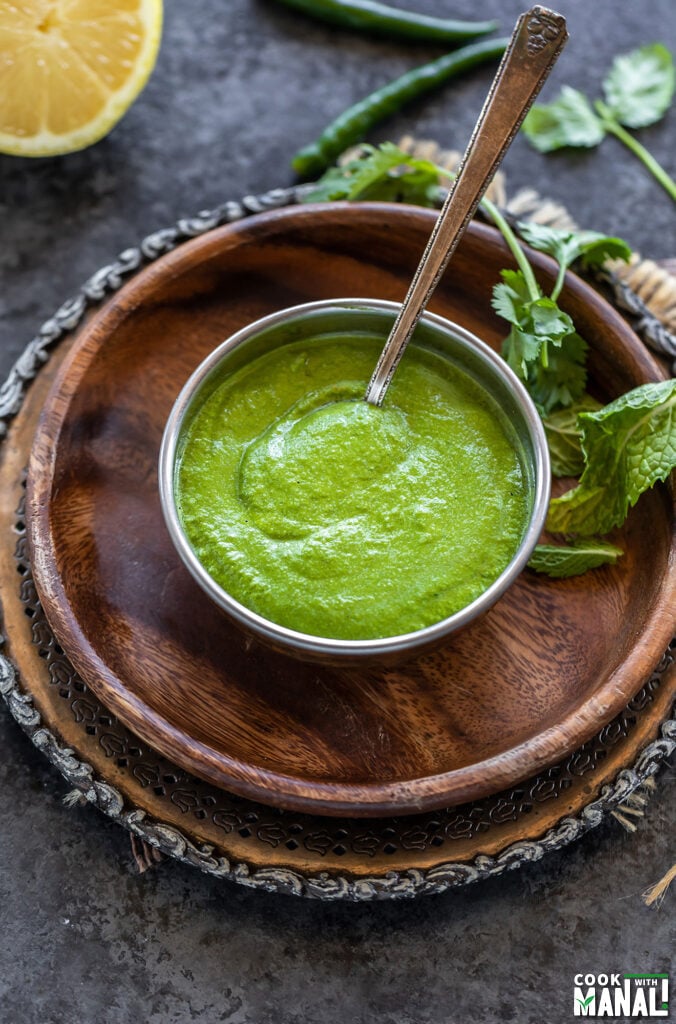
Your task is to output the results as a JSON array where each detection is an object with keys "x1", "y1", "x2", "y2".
[{"x1": 522, "y1": 85, "x2": 605, "y2": 153}]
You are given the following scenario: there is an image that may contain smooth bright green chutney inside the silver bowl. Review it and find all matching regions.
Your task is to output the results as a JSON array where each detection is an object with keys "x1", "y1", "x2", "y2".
[{"x1": 175, "y1": 335, "x2": 531, "y2": 640}]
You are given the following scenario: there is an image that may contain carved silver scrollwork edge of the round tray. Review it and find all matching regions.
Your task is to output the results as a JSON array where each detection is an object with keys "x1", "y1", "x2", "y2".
[{"x1": 0, "y1": 188, "x2": 676, "y2": 901}]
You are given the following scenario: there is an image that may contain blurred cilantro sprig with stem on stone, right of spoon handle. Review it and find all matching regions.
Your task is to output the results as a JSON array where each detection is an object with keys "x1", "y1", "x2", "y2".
[{"x1": 522, "y1": 43, "x2": 676, "y2": 202}]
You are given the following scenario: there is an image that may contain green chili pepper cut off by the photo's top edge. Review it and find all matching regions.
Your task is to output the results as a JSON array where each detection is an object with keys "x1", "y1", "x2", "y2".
[{"x1": 272, "y1": 0, "x2": 498, "y2": 43}]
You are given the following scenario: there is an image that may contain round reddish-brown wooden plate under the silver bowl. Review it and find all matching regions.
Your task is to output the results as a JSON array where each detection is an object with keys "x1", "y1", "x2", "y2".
[{"x1": 27, "y1": 204, "x2": 676, "y2": 815}]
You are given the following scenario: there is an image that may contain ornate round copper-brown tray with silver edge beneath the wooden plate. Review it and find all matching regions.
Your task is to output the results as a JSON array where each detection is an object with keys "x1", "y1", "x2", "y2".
[{"x1": 0, "y1": 194, "x2": 676, "y2": 900}]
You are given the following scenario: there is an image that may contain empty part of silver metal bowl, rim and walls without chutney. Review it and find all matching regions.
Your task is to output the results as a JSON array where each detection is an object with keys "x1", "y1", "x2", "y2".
[{"x1": 159, "y1": 299, "x2": 550, "y2": 664}]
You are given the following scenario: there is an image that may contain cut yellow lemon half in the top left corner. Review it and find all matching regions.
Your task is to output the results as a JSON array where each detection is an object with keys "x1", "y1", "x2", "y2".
[{"x1": 0, "y1": 0, "x2": 162, "y2": 157}]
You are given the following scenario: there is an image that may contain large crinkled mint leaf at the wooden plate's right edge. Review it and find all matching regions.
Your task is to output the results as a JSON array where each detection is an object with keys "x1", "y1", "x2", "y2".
[{"x1": 547, "y1": 380, "x2": 676, "y2": 537}]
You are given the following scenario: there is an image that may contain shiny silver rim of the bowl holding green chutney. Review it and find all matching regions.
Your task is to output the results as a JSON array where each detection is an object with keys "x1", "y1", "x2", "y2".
[{"x1": 158, "y1": 298, "x2": 551, "y2": 660}]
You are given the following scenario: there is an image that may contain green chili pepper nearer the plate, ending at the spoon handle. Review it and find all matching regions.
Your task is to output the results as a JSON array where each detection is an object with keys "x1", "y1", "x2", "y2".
[{"x1": 291, "y1": 39, "x2": 509, "y2": 178}]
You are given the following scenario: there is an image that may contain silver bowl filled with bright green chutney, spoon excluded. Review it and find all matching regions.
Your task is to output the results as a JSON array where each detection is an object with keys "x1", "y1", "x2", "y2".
[{"x1": 159, "y1": 299, "x2": 550, "y2": 664}]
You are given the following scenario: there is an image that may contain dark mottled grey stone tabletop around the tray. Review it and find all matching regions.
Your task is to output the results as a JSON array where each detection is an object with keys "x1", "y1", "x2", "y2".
[{"x1": 0, "y1": 0, "x2": 676, "y2": 1024}]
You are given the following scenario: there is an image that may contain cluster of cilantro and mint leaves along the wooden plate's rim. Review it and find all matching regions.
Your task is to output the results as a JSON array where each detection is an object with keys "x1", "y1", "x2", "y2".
[{"x1": 302, "y1": 140, "x2": 676, "y2": 579}]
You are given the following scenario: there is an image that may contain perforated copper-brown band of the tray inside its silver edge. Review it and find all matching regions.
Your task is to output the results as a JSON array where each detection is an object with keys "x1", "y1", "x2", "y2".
[{"x1": 0, "y1": 356, "x2": 676, "y2": 878}]
